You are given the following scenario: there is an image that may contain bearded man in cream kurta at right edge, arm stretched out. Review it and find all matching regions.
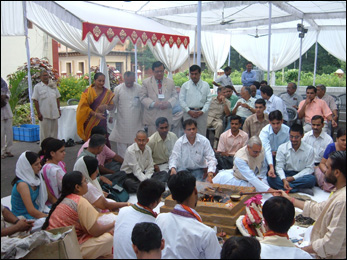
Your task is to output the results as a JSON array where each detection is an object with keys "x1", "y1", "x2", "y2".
[{"x1": 281, "y1": 151, "x2": 346, "y2": 259}]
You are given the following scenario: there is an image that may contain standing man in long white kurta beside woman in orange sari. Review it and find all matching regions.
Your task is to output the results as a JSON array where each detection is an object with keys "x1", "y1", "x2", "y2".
[{"x1": 109, "y1": 71, "x2": 143, "y2": 158}]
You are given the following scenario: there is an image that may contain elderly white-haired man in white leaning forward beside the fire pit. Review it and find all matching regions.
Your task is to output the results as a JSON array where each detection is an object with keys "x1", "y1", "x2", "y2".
[{"x1": 212, "y1": 136, "x2": 275, "y2": 192}]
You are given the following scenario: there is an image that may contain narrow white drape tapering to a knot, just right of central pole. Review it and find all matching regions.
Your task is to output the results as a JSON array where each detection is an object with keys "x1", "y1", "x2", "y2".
[{"x1": 201, "y1": 31, "x2": 230, "y2": 80}]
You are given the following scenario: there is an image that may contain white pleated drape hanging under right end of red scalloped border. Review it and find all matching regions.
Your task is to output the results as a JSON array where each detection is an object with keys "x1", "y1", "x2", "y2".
[{"x1": 148, "y1": 42, "x2": 188, "y2": 79}]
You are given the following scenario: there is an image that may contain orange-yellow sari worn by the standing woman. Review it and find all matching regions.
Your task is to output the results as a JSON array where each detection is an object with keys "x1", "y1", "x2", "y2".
[{"x1": 76, "y1": 85, "x2": 114, "y2": 141}]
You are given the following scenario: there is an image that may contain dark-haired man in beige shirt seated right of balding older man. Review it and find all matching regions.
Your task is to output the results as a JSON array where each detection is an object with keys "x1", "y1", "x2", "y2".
[{"x1": 148, "y1": 117, "x2": 178, "y2": 172}]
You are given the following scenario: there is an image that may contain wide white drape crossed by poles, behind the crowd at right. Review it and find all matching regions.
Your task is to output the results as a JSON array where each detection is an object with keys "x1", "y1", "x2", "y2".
[{"x1": 231, "y1": 30, "x2": 317, "y2": 83}]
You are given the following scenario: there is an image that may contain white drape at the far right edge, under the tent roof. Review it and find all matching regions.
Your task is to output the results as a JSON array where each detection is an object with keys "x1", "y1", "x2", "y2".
[{"x1": 318, "y1": 28, "x2": 346, "y2": 61}]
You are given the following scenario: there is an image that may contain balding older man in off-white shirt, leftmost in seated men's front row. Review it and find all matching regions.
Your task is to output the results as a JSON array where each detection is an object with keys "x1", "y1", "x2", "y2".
[{"x1": 120, "y1": 130, "x2": 169, "y2": 193}]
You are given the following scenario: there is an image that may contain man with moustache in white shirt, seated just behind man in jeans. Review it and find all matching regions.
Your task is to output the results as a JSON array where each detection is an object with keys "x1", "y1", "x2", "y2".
[{"x1": 302, "y1": 115, "x2": 334, "y2": 166}]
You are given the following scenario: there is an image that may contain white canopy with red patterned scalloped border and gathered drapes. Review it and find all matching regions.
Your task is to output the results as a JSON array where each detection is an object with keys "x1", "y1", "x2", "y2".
[{"x1": 1, "y1": 1, "x2": 189, "y2": 87}]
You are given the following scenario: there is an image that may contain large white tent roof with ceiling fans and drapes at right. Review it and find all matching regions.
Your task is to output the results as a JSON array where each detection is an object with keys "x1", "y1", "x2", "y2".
[{"x1": 109, "y1": 1, "x2": 346, "y2": 86}]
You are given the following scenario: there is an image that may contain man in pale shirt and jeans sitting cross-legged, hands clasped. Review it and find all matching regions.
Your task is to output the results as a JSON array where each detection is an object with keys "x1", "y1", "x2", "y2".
[{"x1": 267, "y1": 124, "x2": 316, "y2": 195}]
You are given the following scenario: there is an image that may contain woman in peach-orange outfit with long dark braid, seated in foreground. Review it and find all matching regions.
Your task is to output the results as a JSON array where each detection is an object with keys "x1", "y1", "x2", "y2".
[{"x1": 42, "y1": 171, "x2": 114, "y2": 259}]
